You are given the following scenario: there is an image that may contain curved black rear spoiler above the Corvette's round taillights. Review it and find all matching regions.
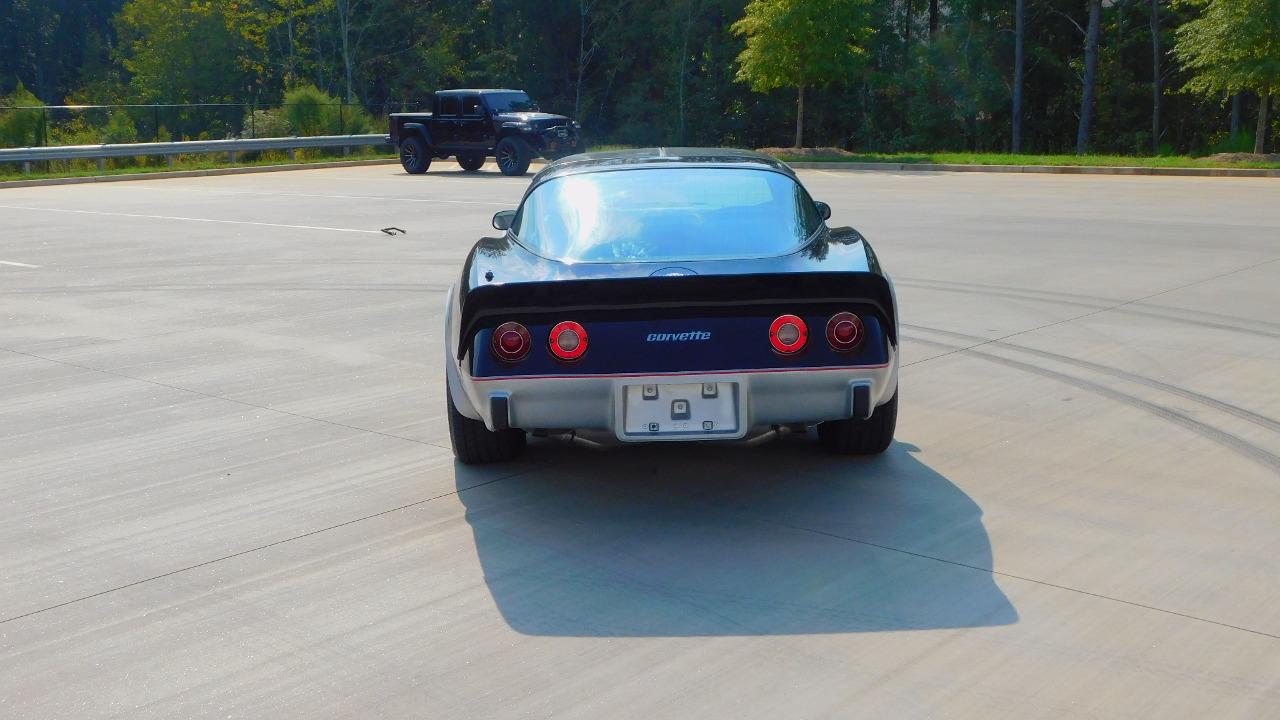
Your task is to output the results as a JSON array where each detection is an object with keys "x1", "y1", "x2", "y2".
[{"x1": 458, "y1": 272, "x2": 897, "y2": 360}]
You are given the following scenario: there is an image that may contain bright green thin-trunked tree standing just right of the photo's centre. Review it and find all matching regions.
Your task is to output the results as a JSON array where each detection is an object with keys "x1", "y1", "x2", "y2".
[{"x1": 733, "y1": 0, "x2": 874, "y2": 147}]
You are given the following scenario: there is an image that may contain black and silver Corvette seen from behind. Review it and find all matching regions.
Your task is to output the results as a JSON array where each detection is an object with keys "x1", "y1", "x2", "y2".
[{"x1": 445, "y1": 150, "x2": 899, "y2": 462}]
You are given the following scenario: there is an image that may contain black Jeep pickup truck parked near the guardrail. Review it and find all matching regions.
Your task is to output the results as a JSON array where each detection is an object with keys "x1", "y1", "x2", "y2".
[{"x1": 387, "y1": 90, "x2": 579, "y2": 176}]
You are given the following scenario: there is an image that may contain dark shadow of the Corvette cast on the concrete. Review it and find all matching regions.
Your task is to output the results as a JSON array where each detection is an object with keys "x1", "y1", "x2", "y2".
[{"x1": 457, "y1": 437, "x2": 1018, "y2": 637}]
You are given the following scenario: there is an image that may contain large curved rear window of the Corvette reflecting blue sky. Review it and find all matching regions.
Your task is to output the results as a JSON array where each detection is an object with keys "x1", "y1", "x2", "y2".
[{"x1": 512, "y1": 168, "x2": 820, "y2": 263}]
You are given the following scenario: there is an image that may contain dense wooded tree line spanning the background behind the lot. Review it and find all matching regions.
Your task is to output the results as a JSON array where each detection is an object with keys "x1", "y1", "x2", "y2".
[{"x1": 0, "y1": 0, "x2": 1280, "y2": 154}]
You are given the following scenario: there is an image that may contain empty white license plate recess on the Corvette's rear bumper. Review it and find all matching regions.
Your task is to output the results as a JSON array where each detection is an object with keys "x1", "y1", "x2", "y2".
[{"x1": 622, "y1": 383, "x2": 740, "y2": 439}]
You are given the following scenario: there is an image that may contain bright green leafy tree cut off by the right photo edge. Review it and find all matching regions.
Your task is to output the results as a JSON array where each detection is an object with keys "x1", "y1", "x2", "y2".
[{"x1": 1174, "y1": 0, "x2": 1280, "y2": 154}]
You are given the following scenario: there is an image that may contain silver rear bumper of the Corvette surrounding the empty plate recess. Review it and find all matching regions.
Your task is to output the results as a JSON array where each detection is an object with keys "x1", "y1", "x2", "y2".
[{"x1": 451, "y1": 347, "x2": 897, "y2": 442}]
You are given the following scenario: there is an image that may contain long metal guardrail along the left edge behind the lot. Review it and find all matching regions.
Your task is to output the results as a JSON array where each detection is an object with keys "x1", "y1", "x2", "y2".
[{"x1": 0, "y1": 135, "x2": 387, "y2": 172}]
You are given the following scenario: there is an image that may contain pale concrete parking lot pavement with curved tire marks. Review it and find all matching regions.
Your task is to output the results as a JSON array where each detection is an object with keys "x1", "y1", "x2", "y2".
[{"x1": 0, "y1": 163, "x2": 1280, "y2": 720}]
